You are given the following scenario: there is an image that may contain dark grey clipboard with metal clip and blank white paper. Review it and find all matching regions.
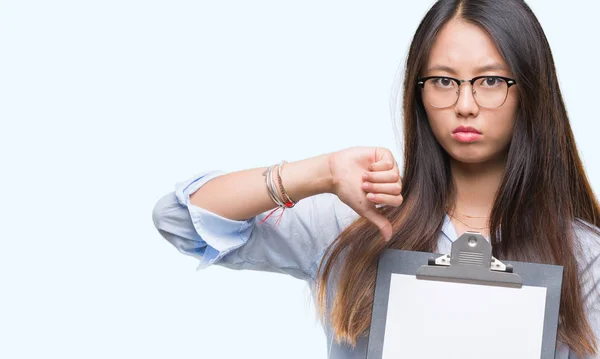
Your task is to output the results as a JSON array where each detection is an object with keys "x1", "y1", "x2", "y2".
[{"x1": 367, "y1": 232, "x2": 563, "y2": 359}]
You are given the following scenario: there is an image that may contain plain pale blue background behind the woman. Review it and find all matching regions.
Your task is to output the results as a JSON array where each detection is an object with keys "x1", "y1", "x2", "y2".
[{"x1": 0, "y1": 0, "x2": 600, "y2": 359}]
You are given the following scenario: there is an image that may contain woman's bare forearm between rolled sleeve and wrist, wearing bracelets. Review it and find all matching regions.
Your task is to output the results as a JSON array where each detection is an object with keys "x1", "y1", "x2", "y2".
[{"x1": 190, "y1": 154, "x2": 332, "y2": 220}]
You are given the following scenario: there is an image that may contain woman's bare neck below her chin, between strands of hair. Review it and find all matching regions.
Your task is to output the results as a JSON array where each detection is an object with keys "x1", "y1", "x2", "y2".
[{"x1": 450, "y1": 155, "x2": 506, "y2": 216}]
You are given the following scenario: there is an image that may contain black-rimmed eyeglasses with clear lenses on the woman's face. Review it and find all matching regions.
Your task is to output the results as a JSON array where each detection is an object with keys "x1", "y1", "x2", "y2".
[{"x1": 417, "y1": 76, "x2": 517, "y2": 108}]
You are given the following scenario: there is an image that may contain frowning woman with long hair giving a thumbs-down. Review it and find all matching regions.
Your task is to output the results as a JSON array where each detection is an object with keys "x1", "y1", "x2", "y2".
[{"x1": 153, "y1": 0, "x2": 600, "y2": 359}]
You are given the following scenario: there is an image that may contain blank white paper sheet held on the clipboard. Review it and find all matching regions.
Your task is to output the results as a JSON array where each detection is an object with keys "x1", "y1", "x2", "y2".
[{"x1": 383, "y1": 274, "x2": 546, "y2": 359}]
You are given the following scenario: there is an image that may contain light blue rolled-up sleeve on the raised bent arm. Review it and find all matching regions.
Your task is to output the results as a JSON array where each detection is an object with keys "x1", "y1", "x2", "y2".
[{"x1": 152, "y1": 171, "x2": 357, "y2": 280}]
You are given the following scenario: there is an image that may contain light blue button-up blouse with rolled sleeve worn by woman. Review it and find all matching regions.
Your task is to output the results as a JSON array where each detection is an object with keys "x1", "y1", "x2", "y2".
[{"x1": 152, "y1": 171, "x2": 600, "y2": 359}]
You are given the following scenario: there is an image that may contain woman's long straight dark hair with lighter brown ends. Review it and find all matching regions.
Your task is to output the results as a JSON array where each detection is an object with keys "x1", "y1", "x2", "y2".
[{"x1": 317, "y1": 0, "x2": 600, "y2": 355}]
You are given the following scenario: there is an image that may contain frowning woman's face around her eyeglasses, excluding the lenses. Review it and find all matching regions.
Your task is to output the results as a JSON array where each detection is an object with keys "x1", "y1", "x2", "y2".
[{"x1": 422, "y1": 19, "x2": 518, "y2": 163}]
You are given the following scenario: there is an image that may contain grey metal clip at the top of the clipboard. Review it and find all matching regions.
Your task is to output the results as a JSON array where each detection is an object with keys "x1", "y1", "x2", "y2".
[{"x1": 417, "y1": 232, "x2": 523, "y2": 288}]
